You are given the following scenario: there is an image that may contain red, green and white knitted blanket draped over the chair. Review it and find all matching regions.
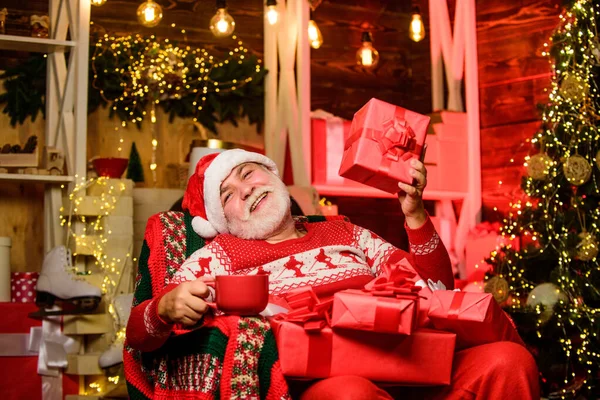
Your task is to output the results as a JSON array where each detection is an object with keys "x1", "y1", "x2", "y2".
[{"x1": 123, "y1": 211, "x2": 324, "y2": 400}]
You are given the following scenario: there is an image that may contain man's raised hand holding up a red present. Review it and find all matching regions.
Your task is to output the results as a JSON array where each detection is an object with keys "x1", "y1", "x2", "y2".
[{"x1": 398, "y1": 159, "x2": 427, "y2": 229}]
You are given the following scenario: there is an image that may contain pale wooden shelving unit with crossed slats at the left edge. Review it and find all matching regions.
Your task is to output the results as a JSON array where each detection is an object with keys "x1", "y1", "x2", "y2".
[{"x1": 0, "y1": 0, "x2": 92, "y2": 396}]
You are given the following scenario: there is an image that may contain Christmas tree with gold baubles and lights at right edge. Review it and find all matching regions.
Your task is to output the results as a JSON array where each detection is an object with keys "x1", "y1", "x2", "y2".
[{"x1": 486, "y1": 0, "x2": 600, "y2": 399}]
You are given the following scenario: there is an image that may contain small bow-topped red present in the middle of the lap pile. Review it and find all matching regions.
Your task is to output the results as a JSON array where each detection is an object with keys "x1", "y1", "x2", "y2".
[{"x1": 331, "y1": 258, "x2": 421, "y2": 335}]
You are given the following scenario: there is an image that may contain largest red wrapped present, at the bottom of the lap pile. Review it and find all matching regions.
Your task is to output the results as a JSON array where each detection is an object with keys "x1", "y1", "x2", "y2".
[{"x1": 274, "y1": 290, "x2": 456, "y2": 385}]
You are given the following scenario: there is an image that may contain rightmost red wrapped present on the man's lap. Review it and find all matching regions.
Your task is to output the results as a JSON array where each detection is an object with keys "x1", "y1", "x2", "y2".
[{"x1": 429, "y1": 290, "x2": 525, "y2": 349}]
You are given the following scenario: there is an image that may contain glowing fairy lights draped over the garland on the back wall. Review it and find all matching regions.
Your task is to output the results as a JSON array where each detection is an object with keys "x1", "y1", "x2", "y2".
[{"x1": 92, "y1": 32, "x2": 263, "y2": 183}]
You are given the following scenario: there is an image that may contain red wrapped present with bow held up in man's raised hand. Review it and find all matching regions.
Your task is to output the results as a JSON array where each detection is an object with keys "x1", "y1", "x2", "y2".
[{"x1": 340, "y1": 99, "x2": 430, "y2": 193}]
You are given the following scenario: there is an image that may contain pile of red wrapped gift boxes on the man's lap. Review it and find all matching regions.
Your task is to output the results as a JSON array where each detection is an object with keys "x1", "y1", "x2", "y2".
[{"x1": 272, "y1": 259, "x2": 523, "y2": 385}]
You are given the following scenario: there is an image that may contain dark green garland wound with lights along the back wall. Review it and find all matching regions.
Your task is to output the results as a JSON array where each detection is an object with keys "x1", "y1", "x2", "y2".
[{"x1": 0, "y1": 35, "x2": 267, "y2": 133}]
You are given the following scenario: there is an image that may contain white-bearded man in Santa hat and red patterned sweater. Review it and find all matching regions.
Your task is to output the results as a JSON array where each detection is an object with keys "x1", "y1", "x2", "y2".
[{"x1": 127, "y1": 150, "x2": 539, "y2": 400}]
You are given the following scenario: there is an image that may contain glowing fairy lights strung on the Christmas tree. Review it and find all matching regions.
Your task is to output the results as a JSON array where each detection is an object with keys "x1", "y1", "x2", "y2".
[{"x1": 492, "y1": 0, "x2": 600, "y2": 398}]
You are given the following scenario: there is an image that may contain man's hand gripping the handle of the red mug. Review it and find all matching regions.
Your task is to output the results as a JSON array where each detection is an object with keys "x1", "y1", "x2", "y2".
[{"x1": 158, "y1": 279, "x2": 210, "y2": 326}]
